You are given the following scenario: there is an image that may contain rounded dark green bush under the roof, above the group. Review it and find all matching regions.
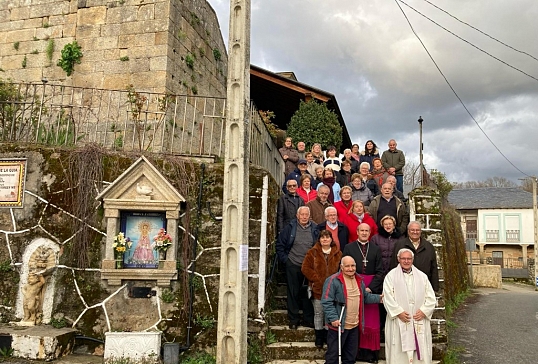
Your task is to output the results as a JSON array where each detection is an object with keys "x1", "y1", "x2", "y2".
[{"x1": 287, "y1": 100, "x2": 342, "y2": 150}]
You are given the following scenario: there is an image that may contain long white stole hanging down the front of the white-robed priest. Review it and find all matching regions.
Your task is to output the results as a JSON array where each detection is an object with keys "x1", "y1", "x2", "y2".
[{"x1": 394, "y1": 264, "x2": 426, "y2": 360}]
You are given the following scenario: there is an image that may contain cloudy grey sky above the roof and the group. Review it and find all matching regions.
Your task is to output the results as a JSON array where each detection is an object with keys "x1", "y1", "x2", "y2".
[{"x1": 209, "y1": 0, "x2": 538, "y2": 183}]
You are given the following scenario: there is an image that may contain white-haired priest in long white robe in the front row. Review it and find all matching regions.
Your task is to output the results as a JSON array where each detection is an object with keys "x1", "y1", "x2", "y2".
[{"x1": 383, "y1": 248, "x2": 436, "y2": 364}]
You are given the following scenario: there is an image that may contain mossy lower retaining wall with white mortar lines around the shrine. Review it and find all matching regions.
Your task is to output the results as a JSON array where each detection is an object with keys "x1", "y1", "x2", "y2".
[{"x1": 0, "y1": 144, "x2": 279, "y2": 346}]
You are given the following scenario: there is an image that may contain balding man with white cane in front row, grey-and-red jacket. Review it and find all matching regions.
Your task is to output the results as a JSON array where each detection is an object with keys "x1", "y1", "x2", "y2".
[{"x1": 321, "y1": 256, "x2": 383, "y2": 364}]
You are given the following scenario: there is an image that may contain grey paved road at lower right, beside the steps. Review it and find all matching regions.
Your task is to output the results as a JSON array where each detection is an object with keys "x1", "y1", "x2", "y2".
[{"x1": 450, "y1": 283, "x2": 538, "y2": 364}]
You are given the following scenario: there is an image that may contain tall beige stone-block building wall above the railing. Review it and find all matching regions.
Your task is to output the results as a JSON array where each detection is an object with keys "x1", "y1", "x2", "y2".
[{"x1": 0, "y1": 0, "x2": 227, "y2": 96}]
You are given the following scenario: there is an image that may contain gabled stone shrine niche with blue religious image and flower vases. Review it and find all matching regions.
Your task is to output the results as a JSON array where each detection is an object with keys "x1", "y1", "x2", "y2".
[{"x1": 97, "y1": 157, "x2": 185, "y2": 286}]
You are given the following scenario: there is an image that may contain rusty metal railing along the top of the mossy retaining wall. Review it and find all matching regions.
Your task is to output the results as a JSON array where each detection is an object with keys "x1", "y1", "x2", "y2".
[{"x1": 0, "y1": 83, "x2": 284, "y2": 188}]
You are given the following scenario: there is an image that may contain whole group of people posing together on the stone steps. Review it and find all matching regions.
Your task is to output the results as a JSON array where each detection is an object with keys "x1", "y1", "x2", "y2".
[{"x1": 276, "y1": 140, "x2": 439, "y2": 363}]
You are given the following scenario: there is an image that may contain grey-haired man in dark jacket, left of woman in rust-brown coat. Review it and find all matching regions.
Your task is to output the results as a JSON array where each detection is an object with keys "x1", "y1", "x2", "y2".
[{"x1": 276, "y1": 206, "x2": 316, "y2": 330}]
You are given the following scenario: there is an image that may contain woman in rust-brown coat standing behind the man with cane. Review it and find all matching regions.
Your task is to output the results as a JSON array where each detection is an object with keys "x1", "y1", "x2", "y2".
[{"x1": 301, "y1": 230, "x2": 342, "y2": 348}]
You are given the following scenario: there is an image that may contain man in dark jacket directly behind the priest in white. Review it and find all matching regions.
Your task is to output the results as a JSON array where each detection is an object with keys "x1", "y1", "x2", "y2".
[{"x1": 390, "y1": 221, "x2": 439, "y2": 292}]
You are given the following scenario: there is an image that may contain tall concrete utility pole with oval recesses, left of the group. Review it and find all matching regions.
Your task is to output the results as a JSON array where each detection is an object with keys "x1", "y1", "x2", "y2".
[{"x1": 217, "y1": 0, "x2": 250, "y2": 364}]
